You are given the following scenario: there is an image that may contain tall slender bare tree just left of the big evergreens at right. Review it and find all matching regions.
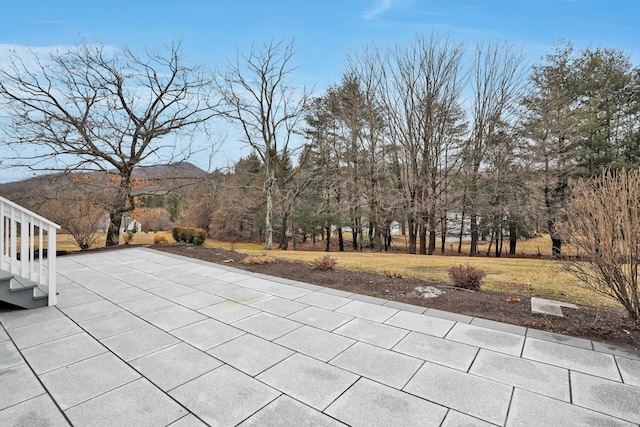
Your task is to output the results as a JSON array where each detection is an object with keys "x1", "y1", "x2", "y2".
[{"x1": 467, "y1": 43, "x2": 526, "y2": 256}]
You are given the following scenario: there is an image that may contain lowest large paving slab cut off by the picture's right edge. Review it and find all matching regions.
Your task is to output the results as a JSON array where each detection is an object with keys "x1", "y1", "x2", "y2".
[{"x1": 571, "y1": 372, "x2": 640, "y2": 424}]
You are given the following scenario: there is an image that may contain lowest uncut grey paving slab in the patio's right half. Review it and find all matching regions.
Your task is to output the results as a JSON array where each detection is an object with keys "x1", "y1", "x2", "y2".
[{"x1": 403, "y1": 362, "x2": 516, "y2": 425}]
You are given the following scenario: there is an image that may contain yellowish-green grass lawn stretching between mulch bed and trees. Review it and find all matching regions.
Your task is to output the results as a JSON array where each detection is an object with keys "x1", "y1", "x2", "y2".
[{"x1": 58, "y1": 232, "x2": 616, "y2": 306}]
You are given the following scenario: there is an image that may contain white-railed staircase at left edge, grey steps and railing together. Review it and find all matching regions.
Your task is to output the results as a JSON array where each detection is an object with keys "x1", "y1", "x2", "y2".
[{"x1": 0, "y1": 197, "x2": 60, "y2": 308}]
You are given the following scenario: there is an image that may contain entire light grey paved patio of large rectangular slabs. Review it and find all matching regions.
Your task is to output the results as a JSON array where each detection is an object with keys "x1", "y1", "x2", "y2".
[{"x1": 0, "y1": 248, "x2": 640, "y2": 427}]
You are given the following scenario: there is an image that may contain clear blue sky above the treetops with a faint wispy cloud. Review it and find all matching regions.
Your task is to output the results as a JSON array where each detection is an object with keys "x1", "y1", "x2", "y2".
[{"x1": 0, "y1": 0, "x2": 640, "y2": 182}]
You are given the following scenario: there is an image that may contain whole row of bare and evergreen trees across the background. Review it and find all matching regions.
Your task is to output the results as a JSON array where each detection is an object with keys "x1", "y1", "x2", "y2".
[{"x1": 0, "y1": 34, "x2": 640, "y2": 256}]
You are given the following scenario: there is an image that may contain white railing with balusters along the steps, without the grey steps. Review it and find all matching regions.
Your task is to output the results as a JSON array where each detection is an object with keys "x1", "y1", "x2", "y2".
[{"x1": 0, "y1": 197, "x2": 60, "y2": 305}]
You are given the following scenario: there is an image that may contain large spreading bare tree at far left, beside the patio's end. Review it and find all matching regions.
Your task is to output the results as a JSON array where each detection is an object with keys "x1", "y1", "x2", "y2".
[{"x1": 0, "y1": 42, "x2": 216, "y2": 246}]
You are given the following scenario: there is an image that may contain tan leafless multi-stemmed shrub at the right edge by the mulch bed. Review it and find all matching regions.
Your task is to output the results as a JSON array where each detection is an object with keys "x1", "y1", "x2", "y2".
[{"x1": 559, "y1": 170, "x2": 640, "y2": 322}]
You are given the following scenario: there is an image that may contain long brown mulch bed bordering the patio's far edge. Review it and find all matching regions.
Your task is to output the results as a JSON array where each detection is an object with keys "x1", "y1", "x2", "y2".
[{"x1": 152, "y1": 245, "x2": 640, "y2": 351}]
